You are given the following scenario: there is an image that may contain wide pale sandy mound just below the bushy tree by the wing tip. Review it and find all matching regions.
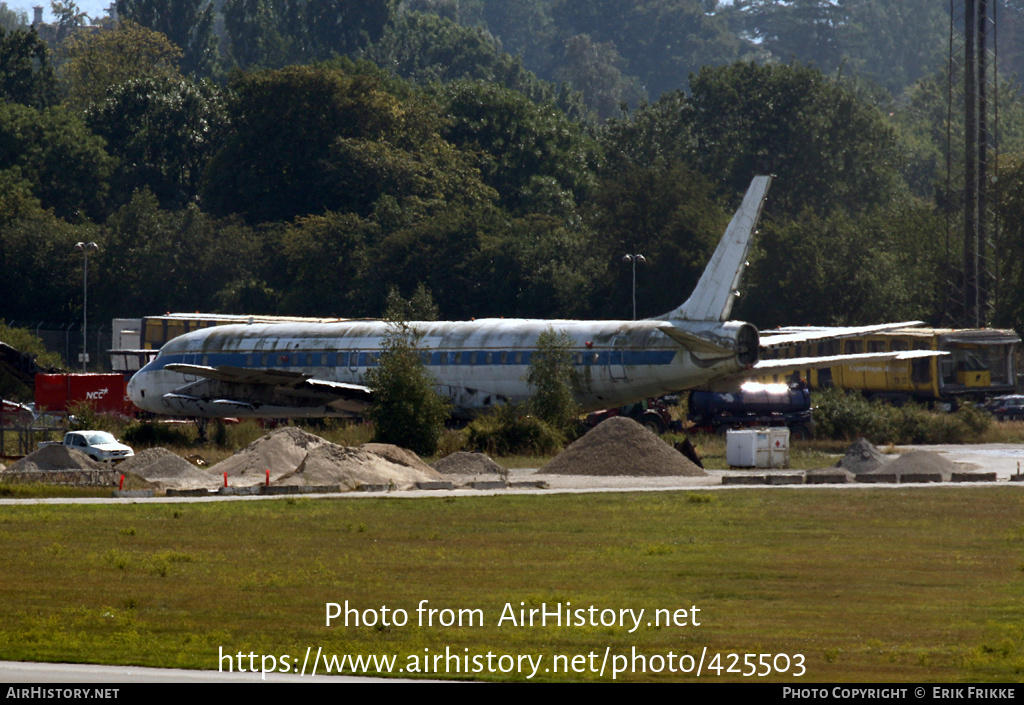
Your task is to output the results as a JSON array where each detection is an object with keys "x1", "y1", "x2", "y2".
[{"x1": 273, "y1": 443, "x2": 441, "y2": 490}]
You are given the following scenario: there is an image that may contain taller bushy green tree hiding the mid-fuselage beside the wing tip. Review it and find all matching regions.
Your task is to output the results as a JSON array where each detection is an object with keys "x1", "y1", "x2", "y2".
[{"x1": 367, "y1": 322, "x2": 449, "y2": 456}]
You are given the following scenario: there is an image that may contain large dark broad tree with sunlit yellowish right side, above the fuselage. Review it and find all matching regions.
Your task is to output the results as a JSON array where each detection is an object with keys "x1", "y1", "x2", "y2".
[{"x1": 205, "y1": 61, "x2": 493, "y2": 222}]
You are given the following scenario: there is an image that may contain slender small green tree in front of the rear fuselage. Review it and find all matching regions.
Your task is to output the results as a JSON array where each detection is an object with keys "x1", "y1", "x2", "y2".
[{"x1": 526, "y1": 328, "x2": 580, "y2": 433}]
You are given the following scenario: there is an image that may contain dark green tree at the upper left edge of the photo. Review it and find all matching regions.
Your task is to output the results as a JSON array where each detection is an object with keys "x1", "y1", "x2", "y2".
[{"x1": 0, "y1": 27, "x2": 57, "y2": 108}]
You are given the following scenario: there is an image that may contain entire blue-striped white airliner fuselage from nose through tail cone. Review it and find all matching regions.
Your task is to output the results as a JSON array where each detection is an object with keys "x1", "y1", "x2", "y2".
[{"x1": 128, "y1": 319, "x2": 757, "y2": 418}]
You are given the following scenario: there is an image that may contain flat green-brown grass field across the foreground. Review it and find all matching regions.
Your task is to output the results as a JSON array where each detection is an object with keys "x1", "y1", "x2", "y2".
[{"x1": 0, "y1": 487, "x2": 1024, "y2": 682}]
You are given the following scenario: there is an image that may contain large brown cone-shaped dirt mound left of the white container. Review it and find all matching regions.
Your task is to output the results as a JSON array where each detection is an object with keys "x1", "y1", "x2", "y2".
[{"x1": 541, "y1": 416, "x2": 707, "y2": 478}]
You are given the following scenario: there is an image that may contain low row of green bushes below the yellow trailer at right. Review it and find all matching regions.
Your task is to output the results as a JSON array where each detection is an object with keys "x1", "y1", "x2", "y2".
[{"x1": 814, "y1": 389, "x2": 992, "y2": 445}]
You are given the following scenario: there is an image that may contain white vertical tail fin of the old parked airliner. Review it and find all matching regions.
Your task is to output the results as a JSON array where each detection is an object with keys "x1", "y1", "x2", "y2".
[{"x1": 666, "y1": 176, "x2": 771, "y2": 321}]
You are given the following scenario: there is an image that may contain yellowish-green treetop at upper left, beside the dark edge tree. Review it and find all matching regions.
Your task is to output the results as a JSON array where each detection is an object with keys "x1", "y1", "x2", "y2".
[{"x1": 59, "y1": 19, "x2": 181, "y2": 111}]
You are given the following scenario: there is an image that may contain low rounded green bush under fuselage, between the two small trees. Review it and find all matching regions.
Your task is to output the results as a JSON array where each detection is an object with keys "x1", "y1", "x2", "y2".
[{"x1": 466, "y1": 405, "x2": 566, "y2": 456}]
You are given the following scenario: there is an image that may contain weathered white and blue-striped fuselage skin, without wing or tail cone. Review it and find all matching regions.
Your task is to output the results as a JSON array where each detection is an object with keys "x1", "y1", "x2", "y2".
[{"x1": 129, "y1": 319, "x2": 744, "y2": 416}]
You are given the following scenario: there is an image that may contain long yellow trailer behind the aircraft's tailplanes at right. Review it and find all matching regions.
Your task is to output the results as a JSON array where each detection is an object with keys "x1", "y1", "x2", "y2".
[{"x1": 761, "y1": 328, "x2": 1021, "y2": 406}]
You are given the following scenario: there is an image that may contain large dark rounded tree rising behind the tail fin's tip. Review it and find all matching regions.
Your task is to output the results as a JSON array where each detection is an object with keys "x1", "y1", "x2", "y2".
[{"x1": 687, "y1": 63, "x2": 899, "y2": 215}]
